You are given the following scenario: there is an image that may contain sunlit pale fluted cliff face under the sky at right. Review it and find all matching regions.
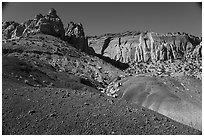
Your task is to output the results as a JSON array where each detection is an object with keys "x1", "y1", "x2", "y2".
[{"x1": 89, "y1": 32, "x2": 202, "y2": 63}]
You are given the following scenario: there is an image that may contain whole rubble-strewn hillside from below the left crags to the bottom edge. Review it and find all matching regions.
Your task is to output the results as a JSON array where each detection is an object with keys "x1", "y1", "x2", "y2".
[{"x1": 2, "y1": 35, "x2": 202, "y2": 135}]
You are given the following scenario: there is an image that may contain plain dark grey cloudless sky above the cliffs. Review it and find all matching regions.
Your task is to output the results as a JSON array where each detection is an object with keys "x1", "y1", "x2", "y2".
[{"x1": 2, "y1": 2, "x2": 202, "y2": 37}]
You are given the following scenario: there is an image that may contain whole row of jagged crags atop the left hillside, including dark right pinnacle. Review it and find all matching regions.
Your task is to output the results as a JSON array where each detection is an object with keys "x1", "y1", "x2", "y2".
[{"x1": 2, "y1": 8, "x2": 91, "y2": 54}]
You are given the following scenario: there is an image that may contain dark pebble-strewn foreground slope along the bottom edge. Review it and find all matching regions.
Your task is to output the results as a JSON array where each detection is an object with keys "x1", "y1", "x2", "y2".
[{"x1": 2, "y1": 86, "x2": 201, "y2": 135}]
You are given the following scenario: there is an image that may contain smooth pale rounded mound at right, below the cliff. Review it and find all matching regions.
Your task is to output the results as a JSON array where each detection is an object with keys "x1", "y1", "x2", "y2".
[{"x1": 107, "y1": 76, "x2": 202, "y2": 130}]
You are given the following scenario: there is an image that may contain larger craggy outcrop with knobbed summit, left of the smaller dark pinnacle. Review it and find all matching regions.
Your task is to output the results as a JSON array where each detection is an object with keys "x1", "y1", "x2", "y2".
[{"x1": 2, "y1": 9, "x2": 65, "y2": 39}]
